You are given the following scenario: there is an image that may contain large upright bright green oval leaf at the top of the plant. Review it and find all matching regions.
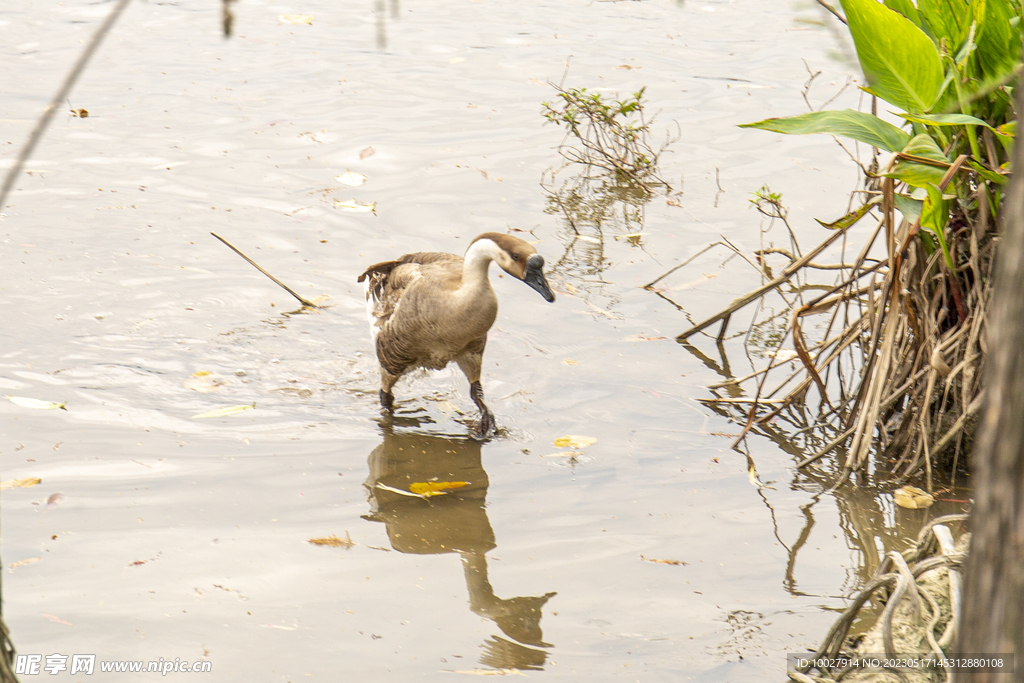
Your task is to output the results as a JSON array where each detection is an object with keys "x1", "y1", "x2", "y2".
[{"x1": 843, "y1": 0, "x2": 942, "y2": 113}]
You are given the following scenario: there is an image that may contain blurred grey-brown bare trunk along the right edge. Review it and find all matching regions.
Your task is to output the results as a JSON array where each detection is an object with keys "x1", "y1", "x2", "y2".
[{"x1": 958, "y1": 72, "x2": 1024, "y2": 683}]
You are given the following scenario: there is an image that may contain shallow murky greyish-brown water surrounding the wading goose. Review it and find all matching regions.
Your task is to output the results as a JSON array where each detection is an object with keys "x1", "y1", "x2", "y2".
[{"x1": 0, "y1": 0, "x2": 965, "y2": 681}]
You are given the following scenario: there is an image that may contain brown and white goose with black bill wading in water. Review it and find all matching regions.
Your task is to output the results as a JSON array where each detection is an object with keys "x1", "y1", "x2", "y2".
[{"x1": 357, "y1": 232, "x2": 555, "y2": 438}]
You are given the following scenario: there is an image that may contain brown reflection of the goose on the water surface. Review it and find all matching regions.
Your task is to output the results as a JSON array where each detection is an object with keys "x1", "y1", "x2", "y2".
[{"x1": 364, "y1": 424, "x2": 555, "y2": 670}]
